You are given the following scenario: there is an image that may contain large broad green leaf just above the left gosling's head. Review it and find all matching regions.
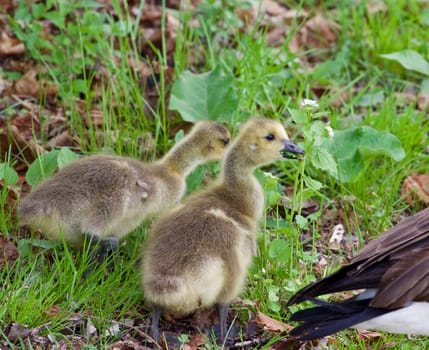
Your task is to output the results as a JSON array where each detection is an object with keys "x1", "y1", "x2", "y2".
[{"x1": 169, "y1": 66, "x2": 238, "y2": 122}]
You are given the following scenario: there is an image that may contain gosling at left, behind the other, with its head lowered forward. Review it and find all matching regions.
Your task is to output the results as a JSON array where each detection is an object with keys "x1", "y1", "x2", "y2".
[{"x1": 19, "y1": 121, "x2": 230, "y2": 262}]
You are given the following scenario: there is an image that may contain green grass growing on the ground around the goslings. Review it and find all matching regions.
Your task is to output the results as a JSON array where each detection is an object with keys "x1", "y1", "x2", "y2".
[{"x1": 0, "y1": 0, "x2": 429, "y2": 349}]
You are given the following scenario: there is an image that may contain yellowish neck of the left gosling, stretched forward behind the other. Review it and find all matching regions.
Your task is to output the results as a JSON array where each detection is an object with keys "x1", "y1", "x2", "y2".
[{"x1": 161, "y1": 139, "x2": 203, "y2": 176}]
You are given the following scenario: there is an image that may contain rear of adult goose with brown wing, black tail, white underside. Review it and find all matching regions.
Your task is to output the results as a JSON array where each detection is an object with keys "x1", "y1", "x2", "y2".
[{"x1": 288, "y1": 208, "x2": 429, "y2": 340}]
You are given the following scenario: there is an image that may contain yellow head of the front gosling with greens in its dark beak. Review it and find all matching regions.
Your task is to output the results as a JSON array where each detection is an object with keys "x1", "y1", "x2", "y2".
[{"x1": 234, "y1": 118, "x2": 304, "y2": 166}]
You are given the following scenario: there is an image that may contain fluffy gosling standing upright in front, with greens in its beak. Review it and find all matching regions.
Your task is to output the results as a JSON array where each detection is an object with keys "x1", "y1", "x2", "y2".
[{"x1": 141, "y1": 118, "x2": 303, "y2": 342}]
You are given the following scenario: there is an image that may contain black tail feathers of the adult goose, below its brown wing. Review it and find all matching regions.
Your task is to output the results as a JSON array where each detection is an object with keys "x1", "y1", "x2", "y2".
[{"x1": 290, "y1": 298, "x2": 393, "y2": 341}]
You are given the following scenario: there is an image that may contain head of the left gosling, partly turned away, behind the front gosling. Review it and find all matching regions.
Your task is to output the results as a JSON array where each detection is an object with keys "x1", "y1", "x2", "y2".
[{"x1": 189, "y1": 120, "x2": 231, "y2": 161}]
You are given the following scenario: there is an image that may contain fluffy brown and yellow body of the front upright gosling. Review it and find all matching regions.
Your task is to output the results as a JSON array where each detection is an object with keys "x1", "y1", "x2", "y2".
[{"x1": 143, "y1": 186, "x2": 263, "y2": 314}]
